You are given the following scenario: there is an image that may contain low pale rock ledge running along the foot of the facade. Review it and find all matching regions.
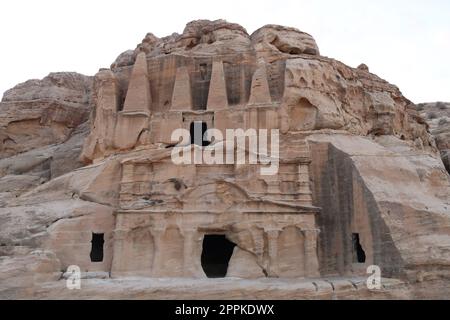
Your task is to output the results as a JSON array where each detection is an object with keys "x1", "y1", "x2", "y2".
[{"x1": 0, "y1": 278, "x2": 412, "y2": 300}]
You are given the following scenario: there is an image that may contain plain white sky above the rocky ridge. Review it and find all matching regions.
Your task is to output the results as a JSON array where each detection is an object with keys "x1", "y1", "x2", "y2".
[{"x1": 0, "y1": 0, "x2": 450, "y2": 103}]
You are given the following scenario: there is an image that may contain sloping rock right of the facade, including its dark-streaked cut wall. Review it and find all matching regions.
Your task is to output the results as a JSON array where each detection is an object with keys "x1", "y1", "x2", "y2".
[{"x1": 308, "y1": 134, "x2": 450, "y2": 282}]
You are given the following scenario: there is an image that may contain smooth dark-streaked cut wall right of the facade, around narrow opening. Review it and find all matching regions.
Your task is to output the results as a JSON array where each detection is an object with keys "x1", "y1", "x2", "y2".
[{"x1": 311, "y1": 143, "x2": 403, "y2": 277}]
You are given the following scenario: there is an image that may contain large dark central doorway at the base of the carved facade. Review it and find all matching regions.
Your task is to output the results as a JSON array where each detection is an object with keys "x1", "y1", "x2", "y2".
[{"x1": 202, "y1": 235, "x2": 236, "y2": 278}]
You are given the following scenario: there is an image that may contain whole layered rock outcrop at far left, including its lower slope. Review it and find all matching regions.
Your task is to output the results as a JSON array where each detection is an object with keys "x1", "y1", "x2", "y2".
[{"x1": 0, "y1": 73, "x2": 92, "y2": 203}]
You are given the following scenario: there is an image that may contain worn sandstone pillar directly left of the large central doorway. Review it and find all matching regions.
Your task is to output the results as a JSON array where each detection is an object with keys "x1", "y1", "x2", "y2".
[{"x1": 181, "y1": 228, "x2": 205, "y2": 278}]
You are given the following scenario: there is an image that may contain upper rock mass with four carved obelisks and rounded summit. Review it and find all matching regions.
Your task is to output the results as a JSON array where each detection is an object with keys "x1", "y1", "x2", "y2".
[{"x1": 90, "y1": 20, "x2": 436, "y2": 163}]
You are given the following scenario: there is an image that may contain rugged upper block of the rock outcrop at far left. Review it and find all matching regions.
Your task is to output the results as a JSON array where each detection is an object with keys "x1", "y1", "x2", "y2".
[{"x1": 0, "y1": 73, "x2": 92, "y2": 159}]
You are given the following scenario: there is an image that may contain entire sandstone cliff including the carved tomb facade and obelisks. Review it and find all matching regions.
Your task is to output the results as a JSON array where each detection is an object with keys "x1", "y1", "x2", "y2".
[{"x1": 0, "y1": 20, "x2": 450, "y2": 298}]
